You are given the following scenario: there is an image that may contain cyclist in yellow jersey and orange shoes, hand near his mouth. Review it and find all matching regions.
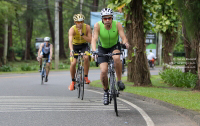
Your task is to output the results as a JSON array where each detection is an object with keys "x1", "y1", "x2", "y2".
[{"x1": 69, "y1": 14, "x2": 92, "y2": 91}]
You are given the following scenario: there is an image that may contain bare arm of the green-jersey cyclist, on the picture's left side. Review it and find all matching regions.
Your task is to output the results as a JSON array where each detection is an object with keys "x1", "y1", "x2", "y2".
[{"x1": 91, "y1": 23, "x2": 99, "y2": 51}]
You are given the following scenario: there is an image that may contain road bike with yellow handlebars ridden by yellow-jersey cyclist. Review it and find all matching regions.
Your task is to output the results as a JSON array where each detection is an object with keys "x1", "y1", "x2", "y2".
[{"x1": 74, "y1": 51, "x2": 91, "y2": 100}]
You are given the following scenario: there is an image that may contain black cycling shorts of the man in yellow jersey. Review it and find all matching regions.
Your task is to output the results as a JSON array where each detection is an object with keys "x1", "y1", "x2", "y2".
[{"x1": 73, "y1": 43, "x2": 90, "y2": 58}]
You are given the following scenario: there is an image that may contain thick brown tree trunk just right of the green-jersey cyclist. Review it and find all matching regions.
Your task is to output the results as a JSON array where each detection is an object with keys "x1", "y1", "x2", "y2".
[{"x1": 126, "y1": 0, "x2": 152, "y2": 86}]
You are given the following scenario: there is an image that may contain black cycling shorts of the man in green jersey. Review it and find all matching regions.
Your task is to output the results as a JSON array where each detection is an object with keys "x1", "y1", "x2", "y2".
[{"x1": 97, "y1": 42, "x2": 121, "y2": 64}]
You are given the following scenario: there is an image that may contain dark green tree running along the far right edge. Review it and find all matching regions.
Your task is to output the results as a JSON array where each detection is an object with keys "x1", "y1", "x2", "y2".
[{"x1": 174, "y1": 0, "x2": 200, "y2": 90}]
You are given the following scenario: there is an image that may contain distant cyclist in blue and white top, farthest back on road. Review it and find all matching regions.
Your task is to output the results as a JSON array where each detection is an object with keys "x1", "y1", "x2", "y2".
[{"x1": 37, "y1": 37, "x2": 53, "y2": 82}]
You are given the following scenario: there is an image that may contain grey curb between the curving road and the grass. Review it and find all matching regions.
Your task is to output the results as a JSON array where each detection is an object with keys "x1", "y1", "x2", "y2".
[{"x1": 88, "y1": 86, "x2": 200, "y2": 126}]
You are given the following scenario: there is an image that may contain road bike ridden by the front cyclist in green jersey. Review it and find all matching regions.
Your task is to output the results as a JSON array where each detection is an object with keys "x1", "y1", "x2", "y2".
[{"x1": 96, "y1": 53, "x2": 122, "y2": 116}]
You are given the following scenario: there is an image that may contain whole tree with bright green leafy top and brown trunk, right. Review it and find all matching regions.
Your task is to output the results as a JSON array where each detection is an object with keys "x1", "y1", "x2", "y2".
[{"x1": 152, "y1": 0, "x2": 180, "y2": 69}]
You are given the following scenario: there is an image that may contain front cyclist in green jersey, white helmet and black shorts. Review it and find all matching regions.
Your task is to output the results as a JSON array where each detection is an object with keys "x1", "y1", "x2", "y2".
[{"x1": 91, "y1": 8, "x2": 129, "y2": 105}]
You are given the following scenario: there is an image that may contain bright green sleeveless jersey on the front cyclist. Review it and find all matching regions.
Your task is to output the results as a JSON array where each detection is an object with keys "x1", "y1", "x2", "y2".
[{"x1": 98, "y1": 20, "x2": 119, "y2": 48}]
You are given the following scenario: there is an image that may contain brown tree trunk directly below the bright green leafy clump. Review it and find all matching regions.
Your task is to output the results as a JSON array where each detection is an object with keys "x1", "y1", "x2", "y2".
[{"x1": 162, "y1": 31, "x2": 178, "y2": 70}]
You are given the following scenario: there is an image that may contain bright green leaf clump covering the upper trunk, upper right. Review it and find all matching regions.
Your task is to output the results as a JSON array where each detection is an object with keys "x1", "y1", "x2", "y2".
[{"x1": 151, "y1": 0, "x2": 180, "y2": 33}]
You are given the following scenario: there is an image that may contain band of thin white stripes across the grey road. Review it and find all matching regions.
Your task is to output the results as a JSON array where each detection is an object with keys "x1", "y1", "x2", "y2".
[{"x1": 0, "y1": 96, "x2": 130, "y2": 112}]
